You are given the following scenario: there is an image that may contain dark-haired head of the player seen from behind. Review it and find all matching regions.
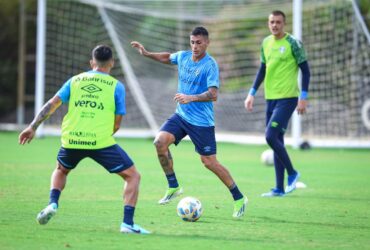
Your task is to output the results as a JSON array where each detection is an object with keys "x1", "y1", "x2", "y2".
[{"x1": 90, "y1": 45, "x2": 114, "y2": 69}]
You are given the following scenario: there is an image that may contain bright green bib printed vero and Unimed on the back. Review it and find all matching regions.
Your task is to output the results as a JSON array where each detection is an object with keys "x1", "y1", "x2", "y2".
[{"x1": 62, "y1": 72, "x2": 118, "y2": 149}]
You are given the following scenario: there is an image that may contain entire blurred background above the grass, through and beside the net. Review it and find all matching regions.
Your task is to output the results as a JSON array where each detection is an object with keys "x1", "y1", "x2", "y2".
[{"x1": 0, "y1": 0, "x2": 370, "y2": 145}]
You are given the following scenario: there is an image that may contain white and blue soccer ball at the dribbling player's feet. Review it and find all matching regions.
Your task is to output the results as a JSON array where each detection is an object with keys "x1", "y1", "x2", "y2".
[{"x1": 177, "y1": 197, "x2": 203, "y2": 222}]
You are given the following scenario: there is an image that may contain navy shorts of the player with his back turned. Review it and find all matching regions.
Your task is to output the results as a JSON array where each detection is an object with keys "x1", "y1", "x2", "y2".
[{"x1": 57, "y1": 144, "x2": 134, "y2": 173}]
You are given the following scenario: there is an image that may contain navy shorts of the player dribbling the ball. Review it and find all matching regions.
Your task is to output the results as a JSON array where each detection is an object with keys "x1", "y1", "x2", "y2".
[{"x1": 160, "y1": 113, "x2": 216, "y2": 155}]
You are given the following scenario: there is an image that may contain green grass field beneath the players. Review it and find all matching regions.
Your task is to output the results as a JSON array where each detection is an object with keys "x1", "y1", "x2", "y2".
[{"x1": 0, "y1": 133, "x2": 370, "y2": 250}]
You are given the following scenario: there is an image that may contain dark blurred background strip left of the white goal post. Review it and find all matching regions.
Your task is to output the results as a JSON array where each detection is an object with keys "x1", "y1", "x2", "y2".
[{"x1": 0, "y1": 0, "x2": 37, "y2": 123}]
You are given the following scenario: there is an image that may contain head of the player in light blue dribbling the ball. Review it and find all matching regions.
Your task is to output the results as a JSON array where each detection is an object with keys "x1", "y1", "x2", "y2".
[{"x1": 190, "y1": 27, "x2": 209, "y2": 59}]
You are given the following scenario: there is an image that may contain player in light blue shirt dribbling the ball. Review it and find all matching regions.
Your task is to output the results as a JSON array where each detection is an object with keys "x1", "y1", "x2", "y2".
[{"x1": 131, "y1": 27, "x2": 248, "y2": 217}]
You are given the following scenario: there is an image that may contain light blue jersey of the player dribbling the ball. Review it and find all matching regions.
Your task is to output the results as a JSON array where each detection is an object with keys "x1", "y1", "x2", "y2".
[{"x1": 170, "y1": 51, "x2": 220, "y2": 127}]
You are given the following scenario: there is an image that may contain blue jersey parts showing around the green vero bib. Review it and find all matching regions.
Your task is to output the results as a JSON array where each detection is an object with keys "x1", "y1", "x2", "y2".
[{"x1": 57, "y1": 70, "x2": 126, "y2": 115}]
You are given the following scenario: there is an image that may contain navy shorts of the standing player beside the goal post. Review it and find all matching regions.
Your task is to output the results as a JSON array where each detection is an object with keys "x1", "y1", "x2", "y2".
[{"x1": 266, "y1": 97, "x2": 298, "y2": 133}]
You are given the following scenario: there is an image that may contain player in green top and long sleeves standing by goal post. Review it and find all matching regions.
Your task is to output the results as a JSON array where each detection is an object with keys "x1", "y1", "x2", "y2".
[{"x1": 244, "y1": 10, "x2": 310, "y2": 197}]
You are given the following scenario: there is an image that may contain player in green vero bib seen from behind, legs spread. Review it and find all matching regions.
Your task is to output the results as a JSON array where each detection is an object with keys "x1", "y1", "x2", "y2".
[{"x1": 19, "y1": 45, "x2": 149, "y2": 234}]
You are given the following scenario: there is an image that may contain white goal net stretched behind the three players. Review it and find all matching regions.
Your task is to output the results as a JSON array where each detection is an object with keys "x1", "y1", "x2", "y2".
[{"x1": 38, "y1": 0, "x2": 370, "y2": 146}]
